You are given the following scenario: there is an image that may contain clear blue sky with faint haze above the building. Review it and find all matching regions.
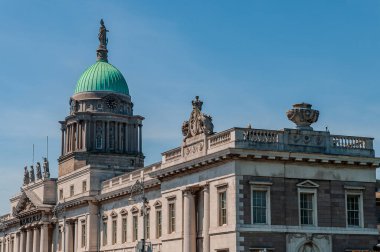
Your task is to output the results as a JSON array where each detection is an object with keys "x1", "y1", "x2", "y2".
[{"x1": 0, "y1": 0, "x2": 380, "y2": 214}]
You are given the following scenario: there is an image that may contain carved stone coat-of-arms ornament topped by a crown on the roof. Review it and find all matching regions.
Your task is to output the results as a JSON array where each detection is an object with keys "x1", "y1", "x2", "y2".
[{"x1": 182, "y1": 96, "x2": 214, "y2": 140}]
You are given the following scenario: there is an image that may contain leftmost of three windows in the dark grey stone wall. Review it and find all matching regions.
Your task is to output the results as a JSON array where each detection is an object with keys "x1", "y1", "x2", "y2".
[{"x1": 252, "y1": 190, "x2": 267, "y2": 224}]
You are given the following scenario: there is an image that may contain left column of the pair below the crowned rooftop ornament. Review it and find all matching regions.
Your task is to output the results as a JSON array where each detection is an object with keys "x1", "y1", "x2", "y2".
[{"x1": 183, "y1": 190, "x2": 196, "y2": 252}]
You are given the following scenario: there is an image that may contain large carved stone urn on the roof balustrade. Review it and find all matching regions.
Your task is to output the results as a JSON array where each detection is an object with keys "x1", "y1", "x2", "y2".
[{"x1": 286, "y1": 103, "x2": 319, "y2": 130}]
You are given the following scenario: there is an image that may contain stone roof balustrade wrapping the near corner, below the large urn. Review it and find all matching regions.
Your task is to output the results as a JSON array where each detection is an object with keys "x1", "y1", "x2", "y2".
[{"x1": 162, "y1": 128, "x2": 374, "y2": 167}]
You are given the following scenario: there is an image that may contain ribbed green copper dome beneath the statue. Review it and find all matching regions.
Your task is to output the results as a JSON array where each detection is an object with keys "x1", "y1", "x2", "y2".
[{"x1": 75, "y1": 60, "x2": 129, "y2": 95}]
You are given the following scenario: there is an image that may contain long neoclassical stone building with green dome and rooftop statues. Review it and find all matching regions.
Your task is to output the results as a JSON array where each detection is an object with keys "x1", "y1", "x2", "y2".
[{"x1": 0, "y1": 22, "x2": 380, "y2": 252}]
